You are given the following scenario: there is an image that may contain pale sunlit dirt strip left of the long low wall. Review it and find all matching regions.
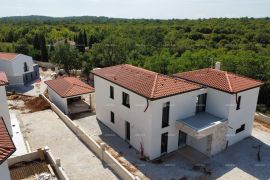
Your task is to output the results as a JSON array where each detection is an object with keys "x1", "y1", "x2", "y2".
[{"x1": 12, "y1": 110, "x2": 118, "y2": 180}]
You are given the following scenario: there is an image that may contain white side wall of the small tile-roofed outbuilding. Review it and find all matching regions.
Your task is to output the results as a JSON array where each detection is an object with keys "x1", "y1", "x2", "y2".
[{"x1": 48, "y1": 87, "x2": 68, "y2": 114}]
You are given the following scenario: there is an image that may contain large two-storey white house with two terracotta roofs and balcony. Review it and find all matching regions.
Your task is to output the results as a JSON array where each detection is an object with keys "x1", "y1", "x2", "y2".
[{"x1": 92, "y1": 64, "x2": 262, "y2": 159}]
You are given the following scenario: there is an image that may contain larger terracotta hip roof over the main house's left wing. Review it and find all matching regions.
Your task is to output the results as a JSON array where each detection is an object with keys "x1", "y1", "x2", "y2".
[{"x1": 92, "y1": 64, "x2": 201, "y2": 99}]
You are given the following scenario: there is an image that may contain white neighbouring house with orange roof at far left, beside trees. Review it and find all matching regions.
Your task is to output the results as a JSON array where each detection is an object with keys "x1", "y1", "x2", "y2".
[{"x1": 0, "y1": 52, "x2": 39, "y2": 85}]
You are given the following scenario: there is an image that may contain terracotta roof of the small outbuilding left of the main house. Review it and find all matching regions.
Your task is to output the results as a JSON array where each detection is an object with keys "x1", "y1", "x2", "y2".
[{"x1": 45, "y1": 77, "x2": 95, "y2": 97}]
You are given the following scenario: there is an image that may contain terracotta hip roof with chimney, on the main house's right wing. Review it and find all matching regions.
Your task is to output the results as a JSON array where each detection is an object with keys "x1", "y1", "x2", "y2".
[{"x1": 176, "y1": 68, "x2": 263, "y2": 93}]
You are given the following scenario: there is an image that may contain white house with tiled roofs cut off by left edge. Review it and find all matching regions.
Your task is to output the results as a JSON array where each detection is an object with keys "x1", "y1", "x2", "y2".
[{"x1": 0, "y1": 72, "x2": 16, "y2": 180}]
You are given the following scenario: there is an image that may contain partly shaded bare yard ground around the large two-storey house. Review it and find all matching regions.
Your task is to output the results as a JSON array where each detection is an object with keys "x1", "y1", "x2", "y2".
[{"x1": 74, "y1": 113, "x2": 270, "y2": 179}]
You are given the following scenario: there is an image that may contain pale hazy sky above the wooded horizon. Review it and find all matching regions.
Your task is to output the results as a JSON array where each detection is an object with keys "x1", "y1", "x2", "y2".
[{"x1": 0, "y1": 0, "x2": 270, "y2": 19}]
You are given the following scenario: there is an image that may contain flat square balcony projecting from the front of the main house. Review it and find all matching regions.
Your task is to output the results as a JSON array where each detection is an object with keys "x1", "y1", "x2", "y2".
[{"x1": 175, "y1": 112, "x2": 227, "y2": 139}]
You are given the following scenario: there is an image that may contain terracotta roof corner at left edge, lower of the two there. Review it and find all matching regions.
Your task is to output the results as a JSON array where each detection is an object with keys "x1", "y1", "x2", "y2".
[{"x1": 0, "y1": 117, "x2": 16, "y2": 164}]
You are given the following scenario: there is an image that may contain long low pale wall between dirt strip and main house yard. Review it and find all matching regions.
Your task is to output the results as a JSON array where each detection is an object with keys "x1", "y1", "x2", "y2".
[{"x1": 41, "y1": 95, "x2": 140, "y2": 180}]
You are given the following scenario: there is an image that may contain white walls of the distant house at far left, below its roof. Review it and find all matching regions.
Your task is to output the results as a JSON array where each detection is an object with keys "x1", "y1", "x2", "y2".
[{"x1": 0, "y1": 54, "x2": 39, "y2": 85}]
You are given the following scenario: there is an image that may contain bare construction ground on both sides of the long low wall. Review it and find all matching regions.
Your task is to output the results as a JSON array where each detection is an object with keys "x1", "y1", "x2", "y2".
[{"x1": 9, "y1": 96, "x2": 270, "y2": 179}]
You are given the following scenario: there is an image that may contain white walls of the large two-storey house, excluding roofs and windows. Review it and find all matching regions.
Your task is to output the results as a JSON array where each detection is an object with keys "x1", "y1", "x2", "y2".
[{"x1": 94, "y1": 76, "x2": 259, "y2": 159}]
